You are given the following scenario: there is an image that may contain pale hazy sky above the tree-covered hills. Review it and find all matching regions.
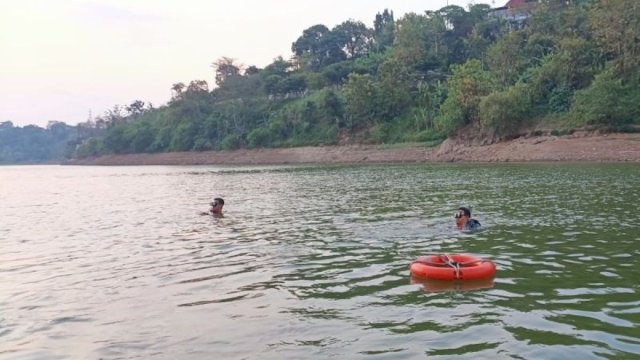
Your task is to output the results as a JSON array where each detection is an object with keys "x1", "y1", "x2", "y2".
[{"x1": 0, "y1": 0, "x2": 496, "y2": 127}]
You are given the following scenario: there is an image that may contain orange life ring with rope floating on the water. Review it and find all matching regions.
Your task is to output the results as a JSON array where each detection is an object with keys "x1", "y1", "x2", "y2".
[{"x1": 410, "y1": 254, "x2": 496, "y2": 280}]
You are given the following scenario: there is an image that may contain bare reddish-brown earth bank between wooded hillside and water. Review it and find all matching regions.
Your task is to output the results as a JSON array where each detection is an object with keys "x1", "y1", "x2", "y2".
[{"x1": 66, "y1": 133, "x2": 640, "y2": 165}]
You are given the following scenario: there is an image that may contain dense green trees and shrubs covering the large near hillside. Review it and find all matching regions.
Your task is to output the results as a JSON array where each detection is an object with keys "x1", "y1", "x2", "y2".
[{"x1": 2, "y1": 0, "x2": 640, "y2": 161}]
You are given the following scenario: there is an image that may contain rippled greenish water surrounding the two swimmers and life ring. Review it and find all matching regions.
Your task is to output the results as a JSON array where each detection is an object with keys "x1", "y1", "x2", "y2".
[{"x1": 0, "y1": 164, "x2": 640, "y2": 359}]
